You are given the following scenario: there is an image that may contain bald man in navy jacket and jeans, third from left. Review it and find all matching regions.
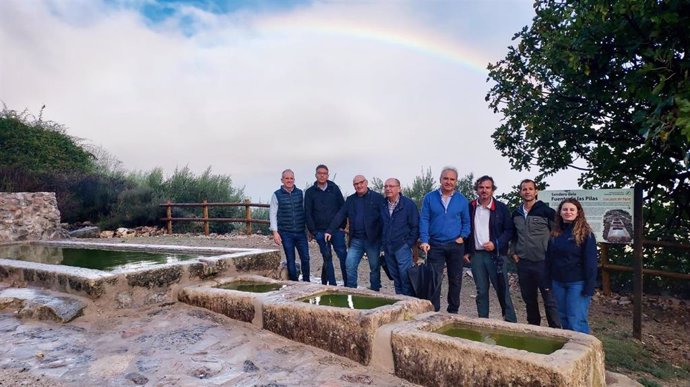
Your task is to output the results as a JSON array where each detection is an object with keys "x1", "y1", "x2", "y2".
[{"x1": 325, "y1": 175, "x2": 384, "y2": 291}]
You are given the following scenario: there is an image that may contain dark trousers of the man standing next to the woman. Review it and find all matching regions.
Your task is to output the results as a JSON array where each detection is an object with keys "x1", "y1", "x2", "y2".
[{"x1": 517, "y1": 259, "x2": 561, "y2": 328}]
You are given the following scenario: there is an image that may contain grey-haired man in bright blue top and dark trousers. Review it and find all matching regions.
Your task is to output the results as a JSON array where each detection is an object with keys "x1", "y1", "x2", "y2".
[{"x1": 419, "y1": 167, "x2": 470, "y2": 314}]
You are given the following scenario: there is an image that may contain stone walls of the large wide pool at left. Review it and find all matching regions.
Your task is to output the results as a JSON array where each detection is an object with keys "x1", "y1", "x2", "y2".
[{"x1": 0, "y1": 241, "x2": 280, "y2": 308}]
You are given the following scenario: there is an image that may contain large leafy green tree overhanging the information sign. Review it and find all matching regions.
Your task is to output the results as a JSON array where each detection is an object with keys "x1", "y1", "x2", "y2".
[{"x1": 486, "y1": 0, "x2": 690, "y2": 294}]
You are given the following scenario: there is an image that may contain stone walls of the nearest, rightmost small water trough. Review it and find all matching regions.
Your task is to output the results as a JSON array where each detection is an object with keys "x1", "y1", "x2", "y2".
[{"x1": 391, "y1": 314, "x2": 606, "y2": 387}]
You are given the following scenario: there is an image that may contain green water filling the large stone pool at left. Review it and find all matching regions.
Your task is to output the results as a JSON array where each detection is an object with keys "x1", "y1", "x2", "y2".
[{"x1": 0, "y1": 246, "x2": 200, "y2": 271}]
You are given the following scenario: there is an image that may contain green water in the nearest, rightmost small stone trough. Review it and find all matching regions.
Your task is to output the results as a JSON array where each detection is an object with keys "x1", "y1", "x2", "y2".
[{"x1": 435, "y1": 324, "x2": 566, "y2": 355}]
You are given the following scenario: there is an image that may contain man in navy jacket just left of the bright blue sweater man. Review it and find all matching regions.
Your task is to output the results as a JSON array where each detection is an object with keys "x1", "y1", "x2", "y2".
[{"x1": 381, "y1": 178, "x2": 419, "y2": 296}]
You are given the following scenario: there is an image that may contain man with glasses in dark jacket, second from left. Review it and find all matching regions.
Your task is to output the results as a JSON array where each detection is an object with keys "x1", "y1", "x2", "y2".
[{"x1": 304, "y1": 164, "x2": 347, "y2": 285}]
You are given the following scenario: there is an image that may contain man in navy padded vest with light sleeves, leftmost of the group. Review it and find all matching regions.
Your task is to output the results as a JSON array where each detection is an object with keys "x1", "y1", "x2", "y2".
[{"x1": 269, "y1": 169, "x2": 309, "y2": 282}]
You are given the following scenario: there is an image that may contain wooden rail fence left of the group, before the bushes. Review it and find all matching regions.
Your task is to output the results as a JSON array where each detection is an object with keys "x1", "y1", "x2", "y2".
[{"x1": 160, "y1": 200, "x2": 270, "y2": 235}]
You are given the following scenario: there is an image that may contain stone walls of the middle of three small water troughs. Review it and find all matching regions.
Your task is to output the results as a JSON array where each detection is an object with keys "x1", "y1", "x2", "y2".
[{"x1": 263, "y1": 284, "x2": 433, "y2": 365}]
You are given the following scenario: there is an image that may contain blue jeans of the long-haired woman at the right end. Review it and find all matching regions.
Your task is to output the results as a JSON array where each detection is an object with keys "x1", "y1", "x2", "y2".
[{"x1": 552, "y1": 280, "x2": 592, "y2": 333}]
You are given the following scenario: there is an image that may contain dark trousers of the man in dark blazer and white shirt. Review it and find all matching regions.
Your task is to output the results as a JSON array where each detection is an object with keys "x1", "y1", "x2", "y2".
[{"x1": 470, "y1": 250, "x2": 517, "y2": 322}]
